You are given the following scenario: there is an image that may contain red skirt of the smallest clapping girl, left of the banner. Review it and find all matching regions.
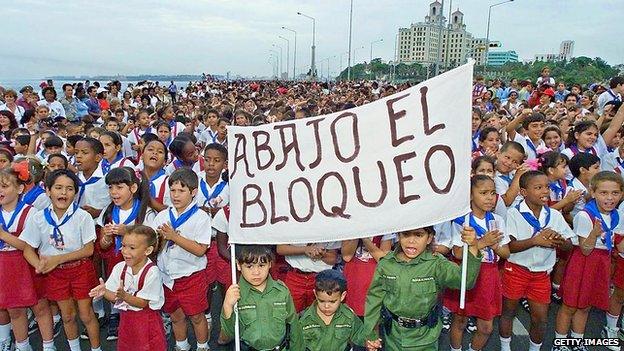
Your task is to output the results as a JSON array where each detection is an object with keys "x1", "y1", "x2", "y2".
[{"x1": 117, "y1": 308, "x2": 167, "y2": 351}]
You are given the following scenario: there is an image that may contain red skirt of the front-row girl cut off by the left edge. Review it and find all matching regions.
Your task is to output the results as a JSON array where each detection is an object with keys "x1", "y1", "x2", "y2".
[{"x1": 0, "y1": 250, "x2": 38, "y2": 309}]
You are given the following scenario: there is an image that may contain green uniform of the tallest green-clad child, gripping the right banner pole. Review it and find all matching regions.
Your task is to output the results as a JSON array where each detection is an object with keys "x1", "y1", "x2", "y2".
[{"x1": 358, "y1": 249, "x2": 481, "y2": 351}]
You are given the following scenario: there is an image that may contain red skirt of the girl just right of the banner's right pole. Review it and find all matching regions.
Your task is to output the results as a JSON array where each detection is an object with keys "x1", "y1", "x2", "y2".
[{"x1": 443, "y1": 262, "x2": 503, "y2": 321}]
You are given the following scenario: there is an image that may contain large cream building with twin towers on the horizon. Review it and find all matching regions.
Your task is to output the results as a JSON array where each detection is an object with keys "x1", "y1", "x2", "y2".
[{"x1": 397, "y1": 0, "x2": 486, "y2": 68}]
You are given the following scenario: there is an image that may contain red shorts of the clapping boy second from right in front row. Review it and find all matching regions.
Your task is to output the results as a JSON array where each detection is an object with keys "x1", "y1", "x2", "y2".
[{"x1": 503, "y1": 261, "x2": 551, "y2": 304}]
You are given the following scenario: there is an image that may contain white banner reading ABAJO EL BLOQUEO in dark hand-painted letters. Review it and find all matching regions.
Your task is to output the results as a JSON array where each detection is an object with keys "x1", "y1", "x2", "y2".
[{"x1": 228, "y1": 63, "x2": 473, "y2": 244}]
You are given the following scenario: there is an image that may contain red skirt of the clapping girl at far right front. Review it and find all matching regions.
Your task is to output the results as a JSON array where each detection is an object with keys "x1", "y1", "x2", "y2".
[{"x1": 559, "y1": 246, "x2": 611, "y2": 311}]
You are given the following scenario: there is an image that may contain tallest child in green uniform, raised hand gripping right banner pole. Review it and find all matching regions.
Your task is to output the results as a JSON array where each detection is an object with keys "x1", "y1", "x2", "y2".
[{"x1": 356, "y1": 227, "x2": 482, "y2": 350}]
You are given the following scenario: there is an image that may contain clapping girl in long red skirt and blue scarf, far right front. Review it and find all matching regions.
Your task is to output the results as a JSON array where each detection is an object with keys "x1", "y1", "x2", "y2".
[{"x1": 553, "y1": 171, "x2": 624, "y2": 350}]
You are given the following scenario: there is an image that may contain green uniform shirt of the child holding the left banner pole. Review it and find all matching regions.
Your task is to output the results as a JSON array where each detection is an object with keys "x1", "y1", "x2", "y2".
[{"x1": 221, "y1": 276, "x2": 303, "y2": 351}]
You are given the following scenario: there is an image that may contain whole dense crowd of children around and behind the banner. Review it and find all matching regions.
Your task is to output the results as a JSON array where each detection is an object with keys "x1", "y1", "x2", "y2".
[{"x1": 0, "y1": 71, "x2": 624, "y2": 351}]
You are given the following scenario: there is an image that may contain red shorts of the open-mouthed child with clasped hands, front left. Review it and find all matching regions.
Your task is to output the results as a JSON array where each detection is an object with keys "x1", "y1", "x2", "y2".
[{"x1": 45, "y1": 259, "x2": 98, "y2": 301}]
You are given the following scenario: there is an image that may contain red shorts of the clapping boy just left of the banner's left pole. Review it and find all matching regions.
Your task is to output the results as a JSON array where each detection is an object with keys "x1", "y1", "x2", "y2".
[{"x1": 162, "y1": 269, "x2": 208, "y2": 316}]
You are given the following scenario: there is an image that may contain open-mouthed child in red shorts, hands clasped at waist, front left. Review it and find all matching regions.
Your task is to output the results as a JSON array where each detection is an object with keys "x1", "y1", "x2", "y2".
[{"x1": 20, "y1": 170, "x2": 101, "y2": 351}]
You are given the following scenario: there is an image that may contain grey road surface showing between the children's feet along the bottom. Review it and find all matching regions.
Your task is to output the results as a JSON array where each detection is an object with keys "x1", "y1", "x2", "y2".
[{"x1": 31, "y1": 288, "x2": 620, "y2": 351}]
